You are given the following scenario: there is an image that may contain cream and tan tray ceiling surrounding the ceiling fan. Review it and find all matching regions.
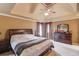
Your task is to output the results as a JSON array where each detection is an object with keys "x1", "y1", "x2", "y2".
[{"x1": 0, "y1": 3, "x2": 79, "y2": 21}]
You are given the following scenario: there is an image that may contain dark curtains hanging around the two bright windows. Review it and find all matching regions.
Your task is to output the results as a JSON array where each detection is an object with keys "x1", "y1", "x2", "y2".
[{"x1": 36, "y1": 22, "x2": 52, "y2": 39}]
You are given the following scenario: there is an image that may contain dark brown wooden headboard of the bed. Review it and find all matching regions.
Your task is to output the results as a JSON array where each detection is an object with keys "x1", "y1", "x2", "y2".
[{"x1": 5, "y1": 29, "x2": 33, "y2": 50}]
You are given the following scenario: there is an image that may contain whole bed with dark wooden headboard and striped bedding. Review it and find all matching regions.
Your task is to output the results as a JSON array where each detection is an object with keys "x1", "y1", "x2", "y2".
[{"x1": 7, "y1": 29, "x2": 53, "y2": 56}]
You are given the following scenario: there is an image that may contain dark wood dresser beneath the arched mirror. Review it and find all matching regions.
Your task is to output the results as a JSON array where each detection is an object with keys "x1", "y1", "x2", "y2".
[{"x1": 54, "y1": 32, "x2": 72, "y2": 44}]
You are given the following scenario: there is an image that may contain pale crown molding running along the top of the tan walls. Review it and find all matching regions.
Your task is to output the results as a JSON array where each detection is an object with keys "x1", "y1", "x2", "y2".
[{"x1": 0, "y1": 13, "x2": 79, "y2": 22}]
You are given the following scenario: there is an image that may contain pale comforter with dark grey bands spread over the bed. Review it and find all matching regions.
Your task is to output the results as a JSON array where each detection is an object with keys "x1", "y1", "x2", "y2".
[{"x1": 11, "y1": 35, "x2": 52, "y2": 56}]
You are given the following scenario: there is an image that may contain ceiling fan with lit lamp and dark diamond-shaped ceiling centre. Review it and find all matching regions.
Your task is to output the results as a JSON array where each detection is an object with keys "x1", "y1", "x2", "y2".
[{"x1": 40, "y1": 3, "x2": 56, "y2": 20}]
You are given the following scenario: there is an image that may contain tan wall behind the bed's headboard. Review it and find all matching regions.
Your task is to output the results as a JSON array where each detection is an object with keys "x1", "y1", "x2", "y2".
[{"x1": 0, "y1": 16, "x2": 35, "y2": 40}]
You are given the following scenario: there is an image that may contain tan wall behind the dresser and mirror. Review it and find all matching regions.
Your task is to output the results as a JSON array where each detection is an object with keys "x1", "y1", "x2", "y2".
[{"x1": 53, "y1": 20, "x2": 79, "y2": 44}]
